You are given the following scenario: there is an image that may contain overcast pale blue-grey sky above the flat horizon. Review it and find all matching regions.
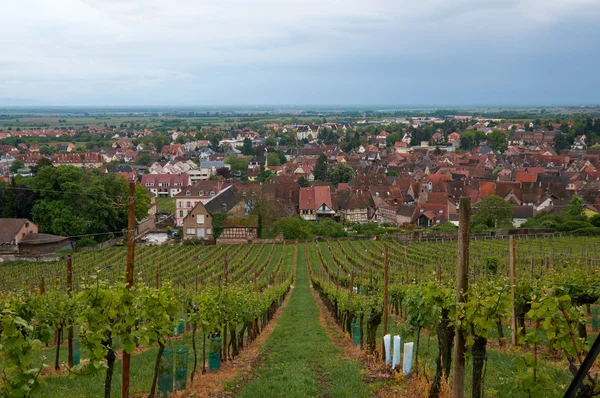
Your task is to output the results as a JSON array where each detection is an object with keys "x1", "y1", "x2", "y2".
[{"x1": 0, "y1": 0, "x2": 600, "y2": 106}]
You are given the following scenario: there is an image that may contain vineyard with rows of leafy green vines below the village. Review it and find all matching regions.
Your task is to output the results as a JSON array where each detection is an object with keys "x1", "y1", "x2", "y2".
[{"x1": 0, "y1": 236, "x2": 600, "y2": 397}]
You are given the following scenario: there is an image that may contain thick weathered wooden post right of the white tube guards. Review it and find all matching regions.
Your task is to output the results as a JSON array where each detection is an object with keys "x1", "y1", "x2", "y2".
[{"x1": 452, "y1": 197, "x2": 471, "y2": 398}]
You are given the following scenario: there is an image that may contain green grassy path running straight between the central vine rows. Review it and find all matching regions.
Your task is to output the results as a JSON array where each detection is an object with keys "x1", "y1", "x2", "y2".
[{"x1": 237, "y1": 246, "x2": 367, "y2": 398}]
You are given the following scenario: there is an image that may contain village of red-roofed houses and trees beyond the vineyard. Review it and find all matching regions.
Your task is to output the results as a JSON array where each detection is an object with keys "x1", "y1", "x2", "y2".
[{"x1": 0, "y1": 110, "x2": 600, "y2": 247}]
